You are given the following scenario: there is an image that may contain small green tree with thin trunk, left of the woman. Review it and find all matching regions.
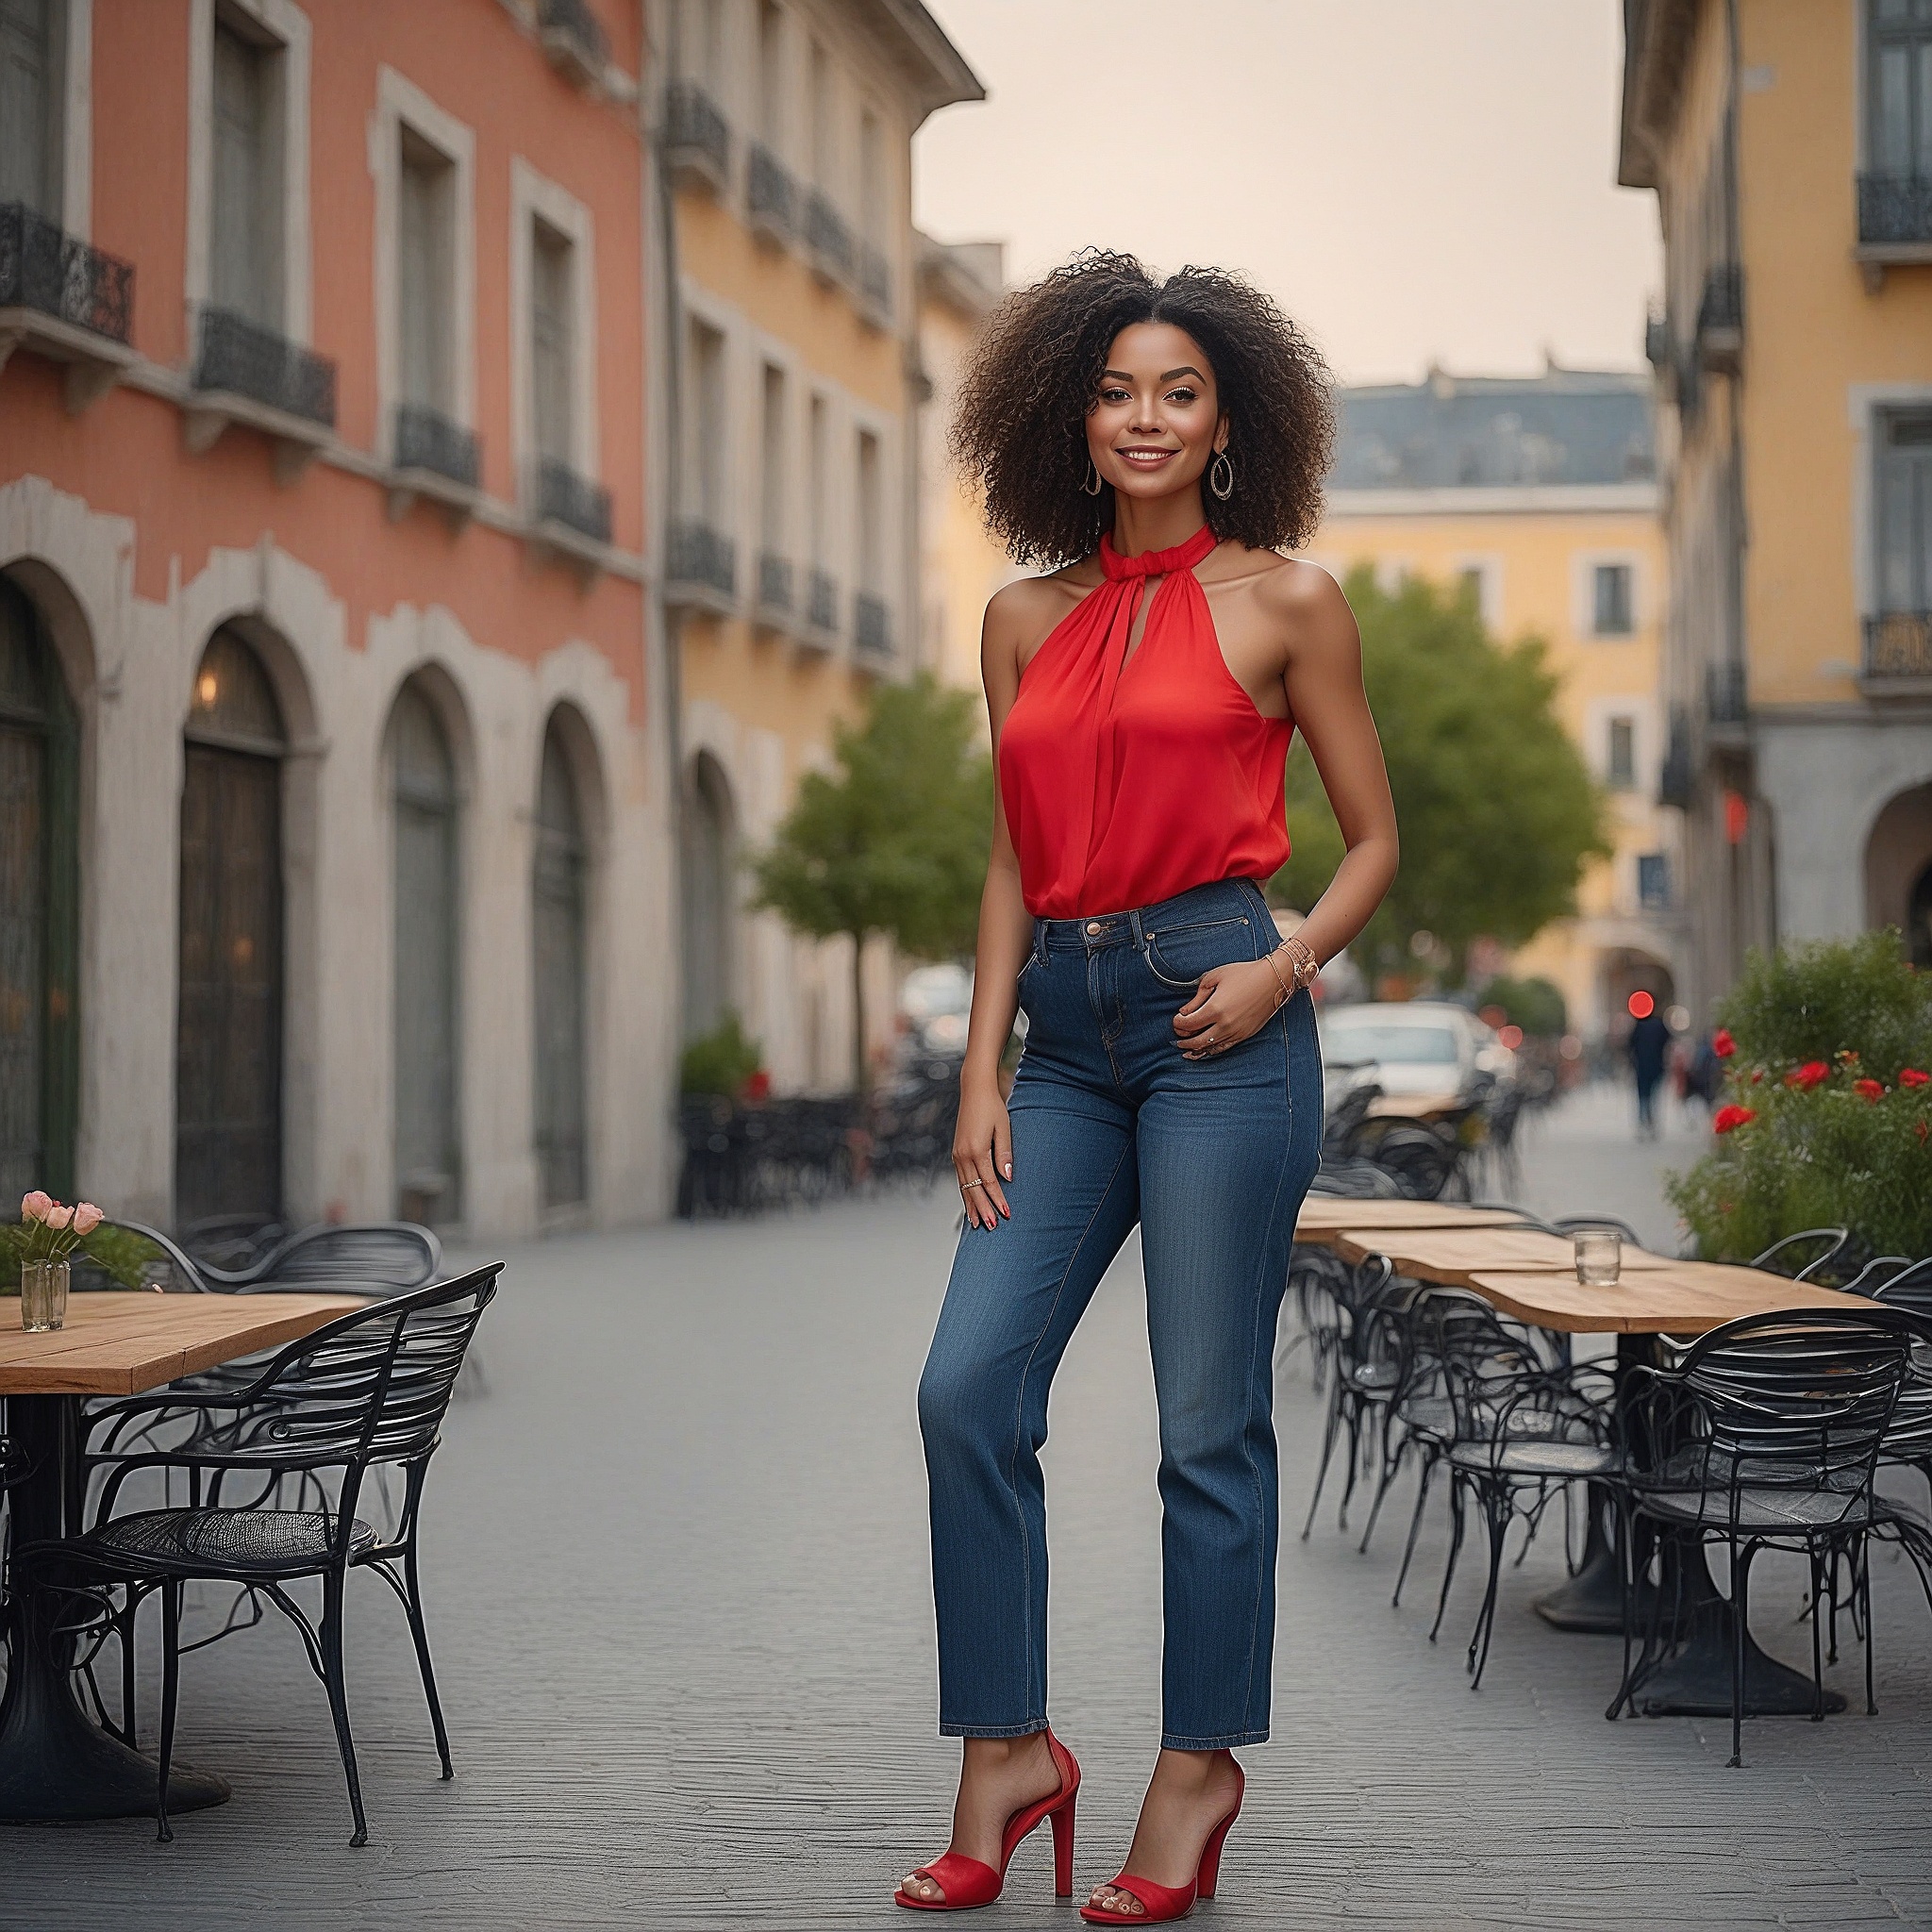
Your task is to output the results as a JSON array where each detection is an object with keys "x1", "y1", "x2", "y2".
[{"x1": 754, "y1": 673, "x2": 993, "y2": 1093}]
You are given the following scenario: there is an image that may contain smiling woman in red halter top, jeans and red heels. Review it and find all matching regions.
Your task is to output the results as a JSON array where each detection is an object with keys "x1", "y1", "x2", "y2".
[{"x1": 894, "y1": 253, "x2": 1395, "y2": 1924}]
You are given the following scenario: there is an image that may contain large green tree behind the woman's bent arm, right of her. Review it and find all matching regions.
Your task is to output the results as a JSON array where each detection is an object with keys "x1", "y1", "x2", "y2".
[{"x1": 1272, "y1": 566, "x2": 1611, "y2": 983}]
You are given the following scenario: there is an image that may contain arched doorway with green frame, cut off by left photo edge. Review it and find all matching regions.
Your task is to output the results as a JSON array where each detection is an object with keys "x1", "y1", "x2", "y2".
[{"x1": 0, "y1": 577, "x2": 79, "y2": 1202}]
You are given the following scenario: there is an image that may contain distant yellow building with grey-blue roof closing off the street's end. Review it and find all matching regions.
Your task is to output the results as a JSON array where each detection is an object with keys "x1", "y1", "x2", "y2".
[{"x1": 1306, "y1": 369, "x2": 1681, "y2": 1038}]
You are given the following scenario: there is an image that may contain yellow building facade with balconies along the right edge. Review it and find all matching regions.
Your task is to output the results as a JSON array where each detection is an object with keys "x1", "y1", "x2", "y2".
[{"x1": 1619, "y1": 0, "x2": 1932, "y2": 1001}]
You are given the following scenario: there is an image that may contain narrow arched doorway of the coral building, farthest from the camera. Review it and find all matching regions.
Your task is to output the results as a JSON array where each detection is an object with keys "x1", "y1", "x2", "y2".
[{"x1": 531, "y1": 711, "x2": 590, "y2": 1208}]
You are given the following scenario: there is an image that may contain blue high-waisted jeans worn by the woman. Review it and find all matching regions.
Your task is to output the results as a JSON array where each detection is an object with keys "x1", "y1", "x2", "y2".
[{"x1": 920, "y1": 879, "x2": 1322, "y2": 1750}]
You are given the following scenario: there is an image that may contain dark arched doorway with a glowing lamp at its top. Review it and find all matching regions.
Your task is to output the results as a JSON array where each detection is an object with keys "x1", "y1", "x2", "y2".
[{"x1": 174, "y1": 625, "x2": 286, "y2": 1226}]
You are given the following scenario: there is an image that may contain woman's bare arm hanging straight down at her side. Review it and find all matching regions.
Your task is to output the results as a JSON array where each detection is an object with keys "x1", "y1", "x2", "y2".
[{"x1": 953, "y1": 581, "x2": 1043, "y2": 1226}]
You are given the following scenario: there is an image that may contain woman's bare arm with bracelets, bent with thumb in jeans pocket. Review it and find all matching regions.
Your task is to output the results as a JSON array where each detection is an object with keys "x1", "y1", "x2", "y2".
[{"x1": 1174, "y1": 564, "x2": 1399, "y2": 1058}]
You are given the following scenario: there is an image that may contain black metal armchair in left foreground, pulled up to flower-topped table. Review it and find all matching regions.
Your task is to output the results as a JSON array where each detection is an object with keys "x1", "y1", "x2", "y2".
[{"x1": 15, "y1": 1261, "x2": 502, "y2": 1845}]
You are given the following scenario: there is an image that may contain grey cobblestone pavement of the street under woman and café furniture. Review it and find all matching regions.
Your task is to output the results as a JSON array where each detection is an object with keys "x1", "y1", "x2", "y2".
[{"x1": 0, "y1": 1108, "x2": 1932, "y2": 1932}]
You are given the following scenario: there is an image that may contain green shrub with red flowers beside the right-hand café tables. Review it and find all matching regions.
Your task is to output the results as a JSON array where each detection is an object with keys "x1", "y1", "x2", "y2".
[{"x1": 1667, "y1": 931, "x2": 1932, "y2": 1261}]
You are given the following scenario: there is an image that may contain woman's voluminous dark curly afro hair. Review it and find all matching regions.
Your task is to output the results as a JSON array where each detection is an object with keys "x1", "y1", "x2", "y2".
[{"x1": 953, "y1": 249, "x2": 1335, "y2": 570}]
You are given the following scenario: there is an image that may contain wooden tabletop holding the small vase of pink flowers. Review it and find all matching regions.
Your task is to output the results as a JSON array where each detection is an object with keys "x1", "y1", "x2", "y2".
[{"x1": 0, "y1": 1292, "x2": 369, "y2": 1395}]
